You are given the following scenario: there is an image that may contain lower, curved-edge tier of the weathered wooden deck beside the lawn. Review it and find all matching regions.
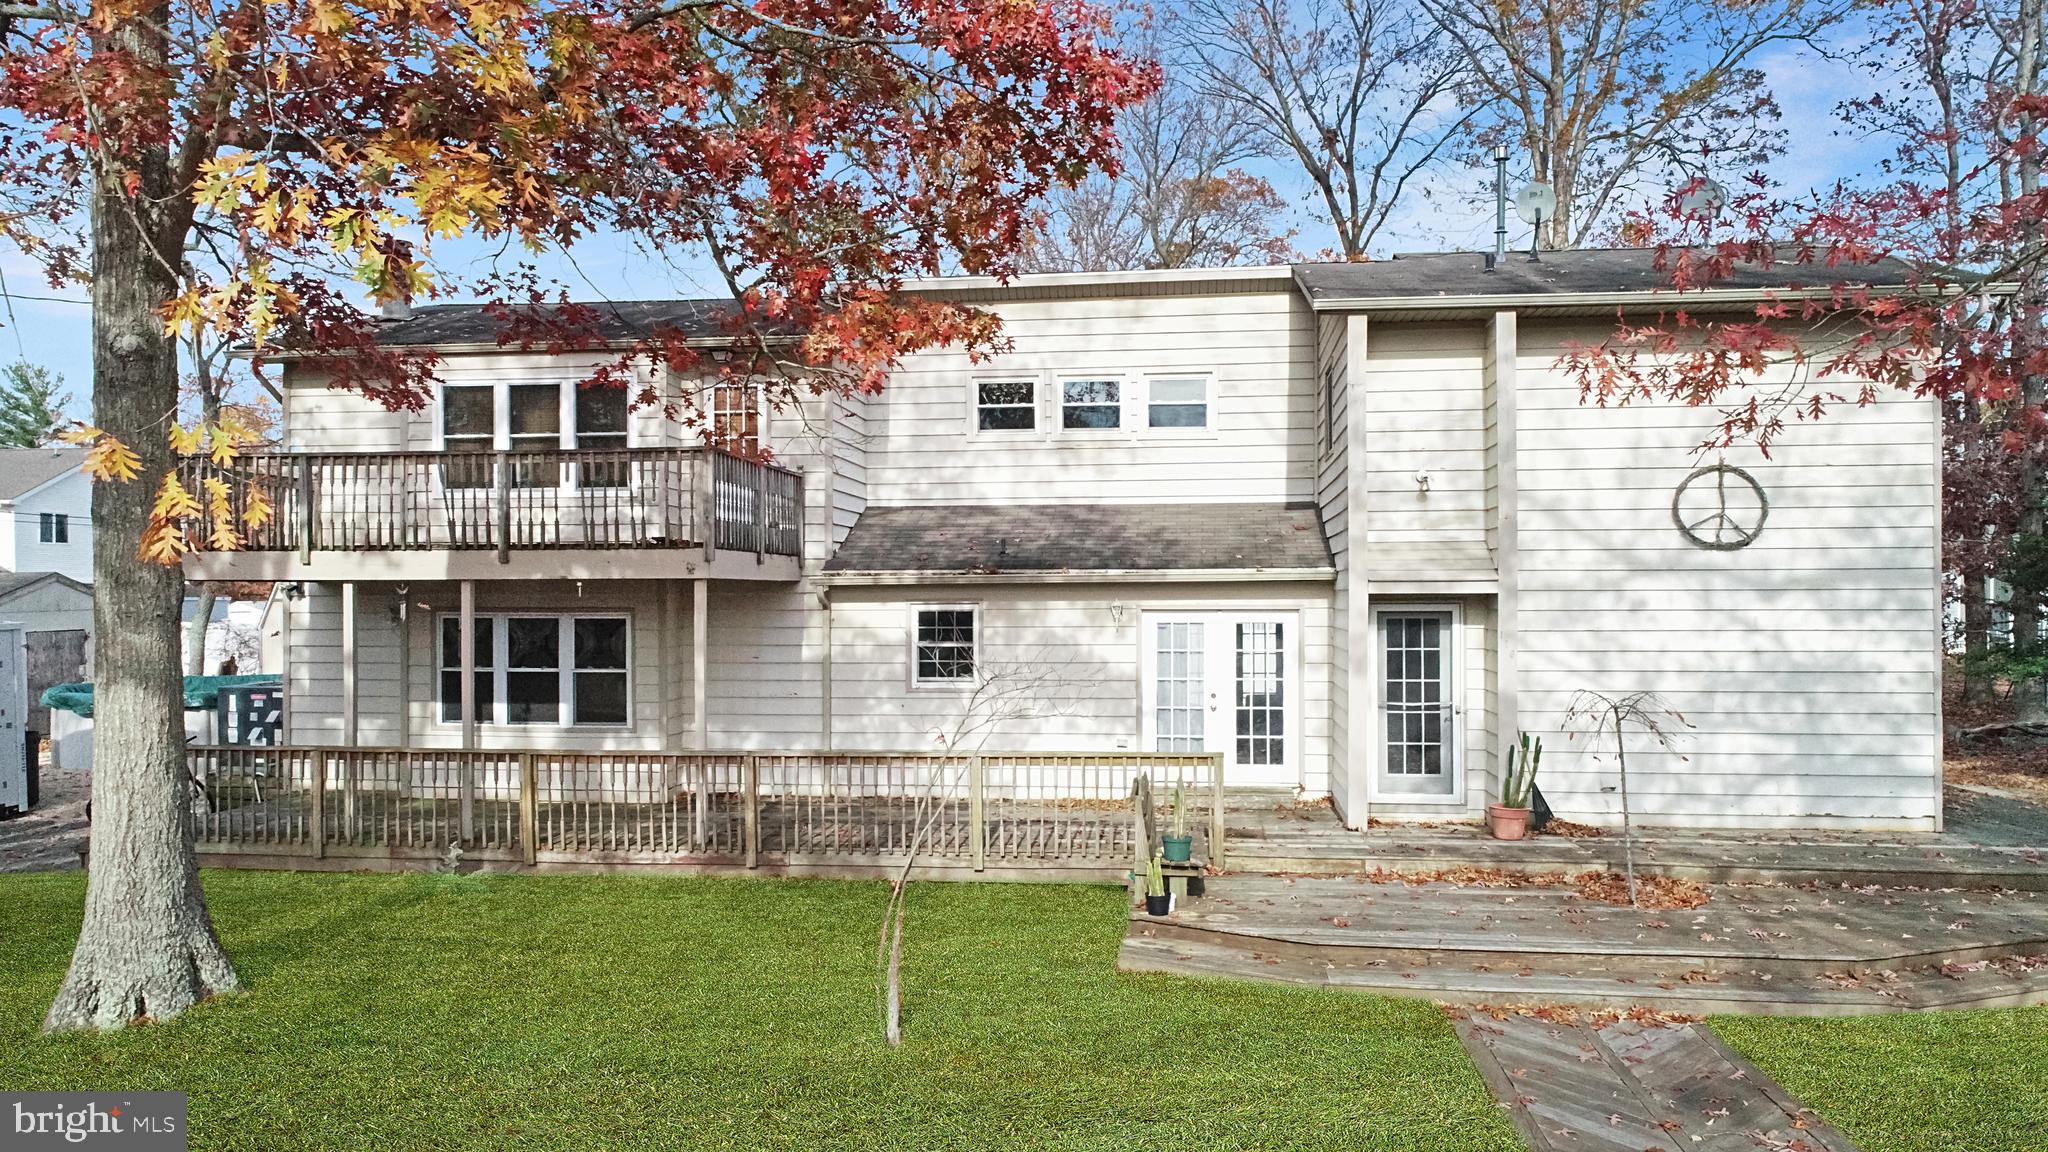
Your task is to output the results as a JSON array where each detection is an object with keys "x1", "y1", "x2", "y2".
[{"x1": 1118, "y1": 875, "x2": 2048, "y2": 1015}]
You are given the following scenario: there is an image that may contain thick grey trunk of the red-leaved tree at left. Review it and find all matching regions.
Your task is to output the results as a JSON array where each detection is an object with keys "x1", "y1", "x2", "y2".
[{"x1": 43, "y1": 12, "x2": 238, "y2": 1031}]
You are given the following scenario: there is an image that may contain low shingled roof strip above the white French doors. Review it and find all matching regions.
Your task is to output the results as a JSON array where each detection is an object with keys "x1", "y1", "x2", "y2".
[{"x1": 825, "y1": 504, "x2": 1331, "y2": 576}]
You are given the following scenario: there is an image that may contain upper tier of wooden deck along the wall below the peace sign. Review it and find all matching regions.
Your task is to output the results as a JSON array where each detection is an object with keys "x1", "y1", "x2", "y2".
[{"x1": 1225, "y1": 791, "x2": 2048, "y2": 892}]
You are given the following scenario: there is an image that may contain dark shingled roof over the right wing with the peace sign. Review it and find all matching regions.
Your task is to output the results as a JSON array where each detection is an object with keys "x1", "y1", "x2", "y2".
[{"x1": 1294, "y1": 248, "x2": 1911, "y2": 312}]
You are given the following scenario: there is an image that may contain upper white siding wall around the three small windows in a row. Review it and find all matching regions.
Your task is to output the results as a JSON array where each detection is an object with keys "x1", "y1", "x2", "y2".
[{"x1": 866, "y1": 291, "x2": 1315, "y2": 504}]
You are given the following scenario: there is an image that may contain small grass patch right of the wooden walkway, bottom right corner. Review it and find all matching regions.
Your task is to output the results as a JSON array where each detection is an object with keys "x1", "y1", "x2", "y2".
[{"x1": 1712, "y1": 1009, "x2": 2048, "y2": 1152}]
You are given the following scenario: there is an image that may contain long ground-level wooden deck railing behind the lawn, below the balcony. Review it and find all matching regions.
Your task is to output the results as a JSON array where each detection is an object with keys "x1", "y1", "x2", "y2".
[{"x1": 188, "y1": 748, "x2": 1223, "y2": 873}]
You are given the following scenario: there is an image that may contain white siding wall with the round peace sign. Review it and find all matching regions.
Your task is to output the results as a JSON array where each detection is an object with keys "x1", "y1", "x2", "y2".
[{"x1": 1501, "y1": 318, "x2": 1942, "y2": 828}]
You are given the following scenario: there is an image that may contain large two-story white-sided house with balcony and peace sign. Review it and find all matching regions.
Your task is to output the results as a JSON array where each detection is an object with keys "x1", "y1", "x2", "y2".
[{"x1": 188, "y1": 252, "x2": 1942, "y2": 828}]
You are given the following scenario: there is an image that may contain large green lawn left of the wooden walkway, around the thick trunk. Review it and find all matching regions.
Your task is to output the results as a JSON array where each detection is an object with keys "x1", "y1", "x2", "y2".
[{"x1": 0, "y1": 871, "x2": 1515, "y2": 1152}]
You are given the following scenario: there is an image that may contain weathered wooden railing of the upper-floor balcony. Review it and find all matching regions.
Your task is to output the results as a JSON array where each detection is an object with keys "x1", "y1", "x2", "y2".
[{"x1": 180, "y1": 449, "x2": 803, "y2": 562}]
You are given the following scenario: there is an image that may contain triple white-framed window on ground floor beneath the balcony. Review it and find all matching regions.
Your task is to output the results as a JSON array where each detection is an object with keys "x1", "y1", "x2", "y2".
[{"x1": 434, "y1": 613, "x2": 633, "y2": 728}]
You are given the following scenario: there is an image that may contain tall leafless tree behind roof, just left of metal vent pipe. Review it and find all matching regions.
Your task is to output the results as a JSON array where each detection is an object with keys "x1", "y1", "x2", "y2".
[{"x1": 1174, "y1": 0, "x2": 1477, "y2": 260}]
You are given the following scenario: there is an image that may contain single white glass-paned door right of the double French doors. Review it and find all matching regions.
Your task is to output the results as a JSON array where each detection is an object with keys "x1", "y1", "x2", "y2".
[{"x1": 1372, "y1": 609, "x2": 1458, "y2": 801}]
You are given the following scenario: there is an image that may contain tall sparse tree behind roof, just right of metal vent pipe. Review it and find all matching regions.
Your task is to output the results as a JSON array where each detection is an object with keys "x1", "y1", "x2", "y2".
[{"x1": 1421, "y1": 0, "x2": 1849, "y2": 248}]
